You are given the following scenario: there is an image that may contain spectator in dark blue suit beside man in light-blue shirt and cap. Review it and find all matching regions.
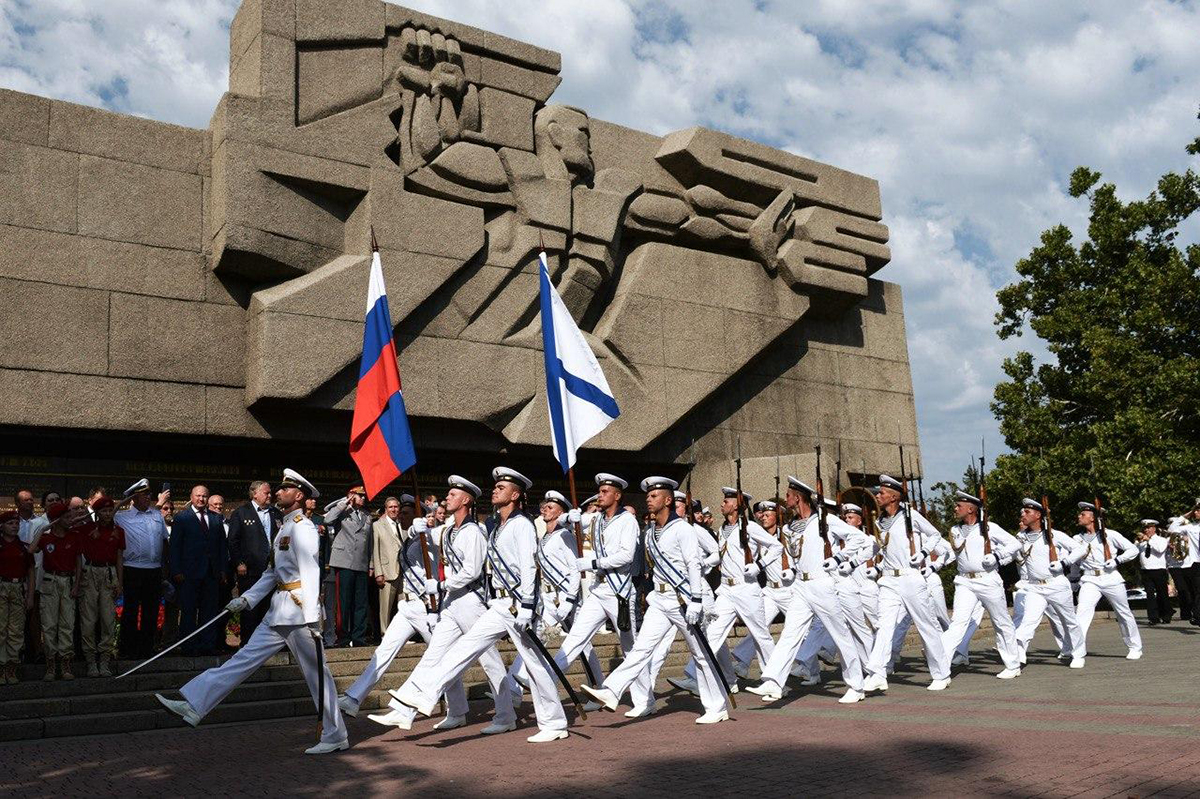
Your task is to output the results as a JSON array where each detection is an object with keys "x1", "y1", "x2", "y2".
[{"x1": 168, "y1": 486, "x2": 229, "y2": 655}]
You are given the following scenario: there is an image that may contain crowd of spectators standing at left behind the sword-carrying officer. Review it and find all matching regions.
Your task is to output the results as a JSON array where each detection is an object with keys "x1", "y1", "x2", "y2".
[{"x1": 0, "y1": 480, "x2": 444, "y2": 685}]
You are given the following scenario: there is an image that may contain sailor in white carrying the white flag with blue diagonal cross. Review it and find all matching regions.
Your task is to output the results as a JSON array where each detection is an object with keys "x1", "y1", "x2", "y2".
[{"x1": 554, "y1": 471, "x2": 655, "y2": 717}]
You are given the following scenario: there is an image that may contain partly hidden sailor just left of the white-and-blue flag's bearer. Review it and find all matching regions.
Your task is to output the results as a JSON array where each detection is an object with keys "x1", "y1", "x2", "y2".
[{"x1": 509, "y1": 491, "x2": 601, "y2": 698}]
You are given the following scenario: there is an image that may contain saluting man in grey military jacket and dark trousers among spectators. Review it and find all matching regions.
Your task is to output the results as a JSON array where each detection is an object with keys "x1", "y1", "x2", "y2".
[{"x1": 325, "y1": 486, "x2": 374, "y2": 647}]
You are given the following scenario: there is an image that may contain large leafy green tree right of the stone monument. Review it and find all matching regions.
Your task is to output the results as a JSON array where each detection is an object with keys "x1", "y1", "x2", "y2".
[{"x1": 988, "y1": 110, "x2": 1200, "y2": 531}]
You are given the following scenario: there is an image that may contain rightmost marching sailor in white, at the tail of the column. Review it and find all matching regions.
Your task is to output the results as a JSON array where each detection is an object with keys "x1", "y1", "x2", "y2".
[{"x1": 1074, "y1": 503, "x2": 1141, "y2": 660}]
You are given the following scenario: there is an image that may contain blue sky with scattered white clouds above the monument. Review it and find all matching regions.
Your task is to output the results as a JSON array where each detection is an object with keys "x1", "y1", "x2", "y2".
[{"x1": 0, "y1": 0, "x2": 1200, "y2": 483}]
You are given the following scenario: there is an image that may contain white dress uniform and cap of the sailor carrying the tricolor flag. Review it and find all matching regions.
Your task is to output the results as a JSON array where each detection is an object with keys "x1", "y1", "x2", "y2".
[{"x1": 370, "y1": 475, "x2": 517, "y2": 733}]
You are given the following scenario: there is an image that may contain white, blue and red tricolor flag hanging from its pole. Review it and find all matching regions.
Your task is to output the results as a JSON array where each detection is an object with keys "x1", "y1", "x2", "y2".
[{"x1": 350, "y1": 250, "x2": 416, "y2": 498}]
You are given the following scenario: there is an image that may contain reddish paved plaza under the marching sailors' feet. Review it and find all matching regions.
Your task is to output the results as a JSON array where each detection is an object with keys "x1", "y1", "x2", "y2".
[{"x1": 0, "y1": 621, "x2": 1200, "y2": 798}]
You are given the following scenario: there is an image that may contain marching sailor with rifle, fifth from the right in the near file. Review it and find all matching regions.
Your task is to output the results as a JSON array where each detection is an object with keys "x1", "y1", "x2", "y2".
[{"x1": 748, "y1": 475, "x2": 863, "y2": 704}]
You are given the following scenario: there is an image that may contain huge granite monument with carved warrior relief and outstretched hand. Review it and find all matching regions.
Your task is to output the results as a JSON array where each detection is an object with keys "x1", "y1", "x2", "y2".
[{"x1": 0, "y1": 0, "x2": 916, "y2": 500}]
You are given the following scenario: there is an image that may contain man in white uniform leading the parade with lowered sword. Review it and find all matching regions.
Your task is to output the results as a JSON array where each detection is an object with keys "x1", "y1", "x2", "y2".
[{"x1": 155, "y1": 469, "x2": 349, "y2": 755}]
